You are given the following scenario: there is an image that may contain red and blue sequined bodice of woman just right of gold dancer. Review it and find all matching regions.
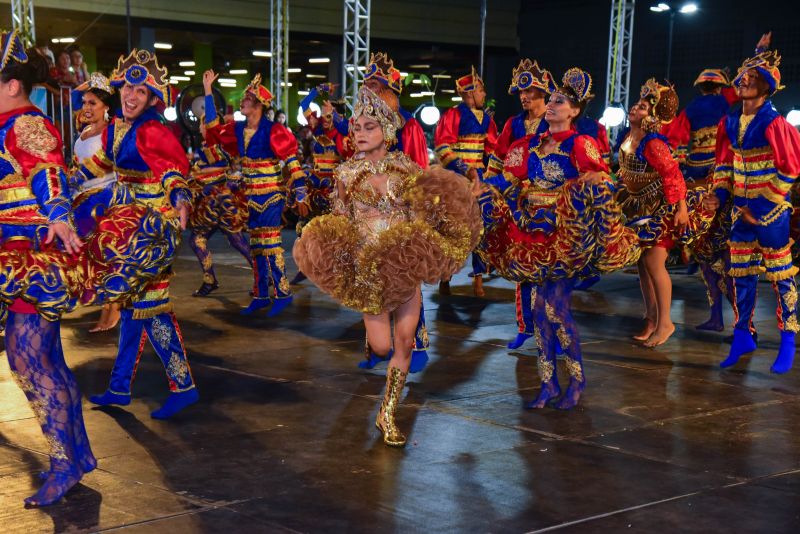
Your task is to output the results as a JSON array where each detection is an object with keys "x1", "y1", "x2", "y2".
[{"x1": 500, "y1": 129, "x2": 608, "y2": 232}]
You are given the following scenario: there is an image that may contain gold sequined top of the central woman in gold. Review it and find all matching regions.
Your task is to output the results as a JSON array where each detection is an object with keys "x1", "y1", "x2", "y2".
[{"x1": 334, "y1": 151, "x2": 422, "y2": 241}]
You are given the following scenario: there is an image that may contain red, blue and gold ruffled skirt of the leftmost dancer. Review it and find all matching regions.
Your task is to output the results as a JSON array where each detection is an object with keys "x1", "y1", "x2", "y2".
[{"x1": 0, "y1": 189, "x2": 181, "y2": 321}]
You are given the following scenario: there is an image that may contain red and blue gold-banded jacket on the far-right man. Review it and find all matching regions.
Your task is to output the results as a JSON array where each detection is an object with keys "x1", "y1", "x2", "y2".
[{"x1": 713, "y1": 100, "x2": 800, "y2": 224}]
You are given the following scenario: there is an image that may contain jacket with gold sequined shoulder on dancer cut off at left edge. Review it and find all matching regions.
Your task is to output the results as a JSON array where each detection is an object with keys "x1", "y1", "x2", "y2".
[{"x1": 0, "y1": 106, "x2": 71, "y2": 248}]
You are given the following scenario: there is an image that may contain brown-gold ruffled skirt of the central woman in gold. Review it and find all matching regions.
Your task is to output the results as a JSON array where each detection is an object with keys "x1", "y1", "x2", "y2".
[{"x1": 292, "y1": 166, "x2": 483, "y2": 314}]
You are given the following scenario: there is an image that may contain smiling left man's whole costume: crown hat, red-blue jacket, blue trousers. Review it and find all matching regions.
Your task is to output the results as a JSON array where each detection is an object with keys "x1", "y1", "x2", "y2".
[{"x1": 73, "y1": 50, "x2": 199, "y2": 418}]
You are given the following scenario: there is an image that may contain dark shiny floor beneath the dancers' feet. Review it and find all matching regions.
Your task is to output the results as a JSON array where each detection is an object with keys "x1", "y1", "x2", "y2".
[{"x1": 0, "y1": 231, "x2": 800, "y2": 533}]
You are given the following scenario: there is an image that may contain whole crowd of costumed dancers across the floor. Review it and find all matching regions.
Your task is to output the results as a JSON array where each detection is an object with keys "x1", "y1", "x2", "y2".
[{"x1": 0, "y1": 25, "x2": 800, "y2": 506}]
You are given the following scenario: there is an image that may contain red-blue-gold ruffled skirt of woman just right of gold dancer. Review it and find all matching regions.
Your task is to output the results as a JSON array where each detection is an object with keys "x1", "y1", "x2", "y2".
[{"x1": 476, "y1": 180, "x2": 641, "y2": 285}]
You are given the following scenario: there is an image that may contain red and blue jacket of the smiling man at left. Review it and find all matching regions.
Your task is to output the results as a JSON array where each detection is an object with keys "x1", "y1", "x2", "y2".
[{"x1": 71, "y1": 107, "x2": 191, "y2": 217}]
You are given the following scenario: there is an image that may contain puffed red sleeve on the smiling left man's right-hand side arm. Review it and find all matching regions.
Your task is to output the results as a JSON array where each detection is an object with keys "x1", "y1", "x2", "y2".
[{"x1": 136, "y1": 120, "x2": 191, "y2": 206}]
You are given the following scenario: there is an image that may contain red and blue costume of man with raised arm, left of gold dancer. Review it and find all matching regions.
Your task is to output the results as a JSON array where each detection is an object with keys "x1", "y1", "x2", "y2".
[{"x1": 205, "y1": 77, "x2": 306, "y2": 312}]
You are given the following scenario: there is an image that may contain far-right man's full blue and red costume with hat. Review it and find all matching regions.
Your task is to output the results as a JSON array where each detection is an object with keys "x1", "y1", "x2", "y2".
[{"x1": 714, "y1": 51, "x2": 800, "y2": 373}]
